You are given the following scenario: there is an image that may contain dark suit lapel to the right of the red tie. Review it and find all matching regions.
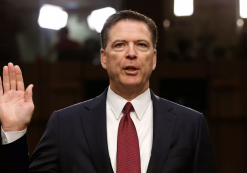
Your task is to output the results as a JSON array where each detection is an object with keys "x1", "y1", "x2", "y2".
[{"x1": 147, "y1": 92, "x2": 176, "y2": 173}]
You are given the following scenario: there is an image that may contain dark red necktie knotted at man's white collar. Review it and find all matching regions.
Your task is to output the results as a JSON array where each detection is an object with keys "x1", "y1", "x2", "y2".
[{"x1": 117, "y1": 102, "x2": 141, "y2": 173}]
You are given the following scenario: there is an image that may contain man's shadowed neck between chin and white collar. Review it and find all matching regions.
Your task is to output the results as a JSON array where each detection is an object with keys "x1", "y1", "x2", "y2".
[{"x1": 110, "y1": 84, "x2": 149, "y2": 101}]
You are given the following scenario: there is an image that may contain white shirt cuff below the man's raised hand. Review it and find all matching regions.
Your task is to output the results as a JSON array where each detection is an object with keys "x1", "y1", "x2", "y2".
[{"x1": 1, "y1": 127, "x2": 27, "y2": 145}]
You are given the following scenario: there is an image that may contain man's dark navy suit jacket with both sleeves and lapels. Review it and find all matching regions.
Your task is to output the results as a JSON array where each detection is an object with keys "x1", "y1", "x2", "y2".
[{"x1": 0, "y1": 90, "x2": 217, "y2": 173}]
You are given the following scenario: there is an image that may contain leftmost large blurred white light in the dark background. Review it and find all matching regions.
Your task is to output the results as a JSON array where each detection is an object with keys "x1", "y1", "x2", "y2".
[{"x1": 38, "y1": 4, "x2": 68, "y2": 30}]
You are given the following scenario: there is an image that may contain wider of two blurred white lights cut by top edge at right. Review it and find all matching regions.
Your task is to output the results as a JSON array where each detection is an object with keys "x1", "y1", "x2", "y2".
[{"x1": 174, "y1": 0, "x2": 194, "y2": 16}]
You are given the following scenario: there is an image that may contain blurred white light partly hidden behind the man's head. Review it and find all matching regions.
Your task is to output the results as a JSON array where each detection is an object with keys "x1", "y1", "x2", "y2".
[{"x1": 87, "y1": 7, "x2": 116, "y2": 33}]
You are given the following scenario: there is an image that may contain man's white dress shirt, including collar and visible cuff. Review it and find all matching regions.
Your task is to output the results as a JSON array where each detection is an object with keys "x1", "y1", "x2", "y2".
[{"x1": 1, "y1": 87, "x2": 153, "y2": 173}]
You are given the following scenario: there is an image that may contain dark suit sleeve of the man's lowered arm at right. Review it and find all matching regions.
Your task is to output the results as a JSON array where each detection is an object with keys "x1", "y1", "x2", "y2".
[{"x1": 193, "y1": 115, "x2": 218, "y2": 173}]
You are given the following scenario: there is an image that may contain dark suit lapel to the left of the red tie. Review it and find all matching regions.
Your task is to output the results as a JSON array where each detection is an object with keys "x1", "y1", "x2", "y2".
[{"x1": 81, "y1": 89, "x2": 113, "y2": 173}]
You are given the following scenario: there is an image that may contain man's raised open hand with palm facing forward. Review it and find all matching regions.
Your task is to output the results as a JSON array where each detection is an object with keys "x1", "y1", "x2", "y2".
[{"x1": 0, "y1": 63, "x2": 34, "y2": 132}]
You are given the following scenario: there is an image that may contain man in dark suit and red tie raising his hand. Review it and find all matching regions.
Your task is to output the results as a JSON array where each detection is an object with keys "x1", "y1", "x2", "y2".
[{"x1": 0, "y1": 10, "x2": 217, "y2": 173}]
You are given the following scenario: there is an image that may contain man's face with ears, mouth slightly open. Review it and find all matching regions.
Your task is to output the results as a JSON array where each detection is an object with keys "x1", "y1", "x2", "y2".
[{"x1": 101, "y1": 20, "x2": 156, "y2": 92}]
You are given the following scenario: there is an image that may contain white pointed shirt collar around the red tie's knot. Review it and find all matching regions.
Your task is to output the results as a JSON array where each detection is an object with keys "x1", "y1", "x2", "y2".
[{"x1": 106, "y1": 87, "x2": 151, "y2": 120}]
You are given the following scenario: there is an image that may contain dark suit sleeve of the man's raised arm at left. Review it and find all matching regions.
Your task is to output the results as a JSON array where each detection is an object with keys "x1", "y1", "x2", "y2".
[{"x1": 0, "y1": 112, "x2": 59, "y2": 173}]
